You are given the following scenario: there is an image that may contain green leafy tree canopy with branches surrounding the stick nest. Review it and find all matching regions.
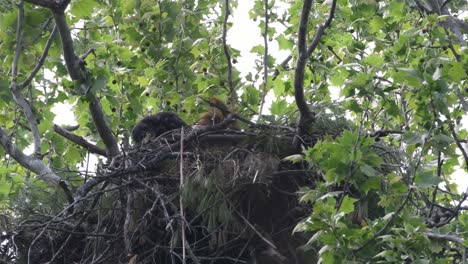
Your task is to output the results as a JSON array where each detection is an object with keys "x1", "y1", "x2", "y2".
[{"x1": 0, "y1": 0, "x2": 468, "y2": 263}]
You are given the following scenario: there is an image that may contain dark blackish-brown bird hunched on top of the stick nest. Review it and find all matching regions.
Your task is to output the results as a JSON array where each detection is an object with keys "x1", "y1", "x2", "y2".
[{"x1": 132, "y1": 112, "x2": 187, "y2": 144}]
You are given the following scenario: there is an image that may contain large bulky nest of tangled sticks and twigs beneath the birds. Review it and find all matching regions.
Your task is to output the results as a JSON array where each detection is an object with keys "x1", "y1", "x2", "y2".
[{"x1": 11, "y1": 127, "x2": 317, "y2": 263}]
